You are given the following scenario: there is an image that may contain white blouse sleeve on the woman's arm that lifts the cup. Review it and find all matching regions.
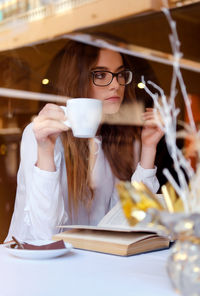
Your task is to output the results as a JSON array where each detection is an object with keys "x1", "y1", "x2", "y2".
[{"x1": 6, "y1": 124, "x2": 68, "y2": 240}]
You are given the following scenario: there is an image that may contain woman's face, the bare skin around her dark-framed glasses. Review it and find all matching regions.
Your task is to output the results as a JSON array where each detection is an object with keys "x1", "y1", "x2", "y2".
[{"x1": 89, "y1": 49, "x2": 125, "y2": 114}]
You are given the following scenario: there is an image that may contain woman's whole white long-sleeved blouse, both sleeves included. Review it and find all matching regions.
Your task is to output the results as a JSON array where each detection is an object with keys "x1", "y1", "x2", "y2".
[{"x1": 6, "y1": 124, "x2": 159, "y2": 241}]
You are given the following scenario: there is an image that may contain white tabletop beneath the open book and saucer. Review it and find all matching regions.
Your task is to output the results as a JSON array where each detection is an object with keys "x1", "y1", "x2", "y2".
[{"x1": 0, "y1": 246, "x2": 177, "y2": 296}]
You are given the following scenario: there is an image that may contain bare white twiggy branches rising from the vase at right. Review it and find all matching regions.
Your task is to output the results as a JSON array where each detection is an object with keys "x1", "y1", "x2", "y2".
[{"x1": 142, "y1": 1, "x2": 200, "y2": 213}]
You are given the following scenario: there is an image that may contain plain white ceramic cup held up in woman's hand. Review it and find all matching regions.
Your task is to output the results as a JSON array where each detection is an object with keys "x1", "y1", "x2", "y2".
[{"x1": 60, "y1": 98, "x2": 102, "y2": 138}]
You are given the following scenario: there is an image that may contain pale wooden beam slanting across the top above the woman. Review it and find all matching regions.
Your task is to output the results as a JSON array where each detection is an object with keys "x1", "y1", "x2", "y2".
[{"x1": 0, "y1": 0, "x2": 162, "y2": 51}]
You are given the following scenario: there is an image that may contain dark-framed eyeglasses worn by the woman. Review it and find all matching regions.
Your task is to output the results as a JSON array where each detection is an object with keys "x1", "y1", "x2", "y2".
[{"x1": 91, "y1": 70, "x2": 133, "y2": 86}]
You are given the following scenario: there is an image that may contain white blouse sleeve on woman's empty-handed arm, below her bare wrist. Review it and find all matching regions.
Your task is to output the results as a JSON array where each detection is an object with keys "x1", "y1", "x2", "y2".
[{"x1": 131, "y1": 163, "x2": 160, "y2": 193}]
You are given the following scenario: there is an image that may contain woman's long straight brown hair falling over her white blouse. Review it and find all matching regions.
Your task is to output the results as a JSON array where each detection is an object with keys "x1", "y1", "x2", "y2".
[{"x1": 57, "y1": 41, "x2": 136, "y2": 213}]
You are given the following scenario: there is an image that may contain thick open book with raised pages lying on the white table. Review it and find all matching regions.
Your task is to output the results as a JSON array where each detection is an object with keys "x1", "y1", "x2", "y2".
[{"x1": 53, "y1": 203, "x2": 170, "y2": 256}]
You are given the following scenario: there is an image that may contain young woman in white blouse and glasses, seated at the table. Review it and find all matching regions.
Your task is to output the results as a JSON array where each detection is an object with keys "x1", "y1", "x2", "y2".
[{"x1": 7, "y1": 41, "x2": 163, "y2": 240}]
